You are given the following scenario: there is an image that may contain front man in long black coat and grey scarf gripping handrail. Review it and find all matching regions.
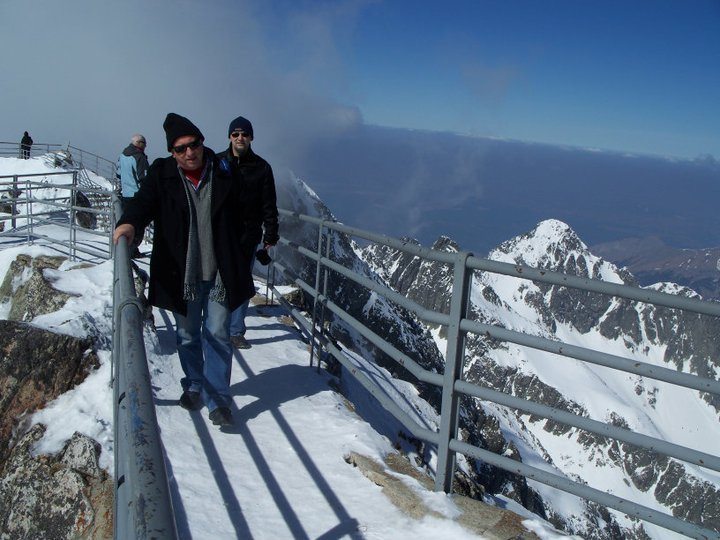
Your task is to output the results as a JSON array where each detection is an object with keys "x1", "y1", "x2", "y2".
[{"x1": 113, "y1": 113, "x2": 255, "y2": 426}]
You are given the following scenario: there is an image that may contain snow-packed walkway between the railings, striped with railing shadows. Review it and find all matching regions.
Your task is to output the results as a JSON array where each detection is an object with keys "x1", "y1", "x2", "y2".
[{"x1": 146, "y1": 294, "x2": 500, "y2": 540}]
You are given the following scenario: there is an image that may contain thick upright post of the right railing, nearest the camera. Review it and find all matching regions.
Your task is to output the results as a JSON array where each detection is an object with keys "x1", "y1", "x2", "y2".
[{"x1": 435, "y1": 252, "x2": 473, "y2": 493}]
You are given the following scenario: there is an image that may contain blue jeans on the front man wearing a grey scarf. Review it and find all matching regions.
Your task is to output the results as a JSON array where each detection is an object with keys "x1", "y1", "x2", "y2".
[{"x1": 173, "y1": 281, "x2": 232, "y2": 412}]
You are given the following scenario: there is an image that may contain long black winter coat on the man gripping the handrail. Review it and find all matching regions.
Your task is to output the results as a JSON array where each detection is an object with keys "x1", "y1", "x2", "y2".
[{"x1": 118, "y1": 147, "x2": 255, "y2": 315}]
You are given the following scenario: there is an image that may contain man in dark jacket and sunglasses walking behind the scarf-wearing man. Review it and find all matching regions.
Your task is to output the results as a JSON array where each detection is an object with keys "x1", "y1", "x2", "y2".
[{"x1": 218, "y1": 116, "x2": 279, "y2": 349}]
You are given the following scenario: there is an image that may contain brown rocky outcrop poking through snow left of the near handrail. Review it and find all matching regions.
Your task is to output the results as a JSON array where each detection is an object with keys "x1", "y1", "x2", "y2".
[{"x1": 0, "y1": 255, "x2": 113, "y2": 540}]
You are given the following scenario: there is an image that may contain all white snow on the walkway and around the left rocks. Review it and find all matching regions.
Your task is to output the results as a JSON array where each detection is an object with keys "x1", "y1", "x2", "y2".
[{"x1": 0, "y1": 153, "x2": 572, "y2": 540}]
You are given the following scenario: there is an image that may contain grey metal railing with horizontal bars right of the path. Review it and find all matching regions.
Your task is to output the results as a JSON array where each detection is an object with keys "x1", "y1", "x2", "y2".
[{"x1": 271, "y1": 210, "x2": 720, "y2": 538}]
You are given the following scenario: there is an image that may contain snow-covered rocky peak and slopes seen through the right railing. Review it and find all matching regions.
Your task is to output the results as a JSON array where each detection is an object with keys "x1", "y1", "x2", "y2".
[{"x1": 365, "y1": 220, "x2": 720, "y2": 538}]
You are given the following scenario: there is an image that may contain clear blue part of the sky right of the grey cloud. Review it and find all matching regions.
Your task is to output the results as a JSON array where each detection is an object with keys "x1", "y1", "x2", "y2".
[{"x1": 316, "y1": 0, "x2": 720, "y2": 157}]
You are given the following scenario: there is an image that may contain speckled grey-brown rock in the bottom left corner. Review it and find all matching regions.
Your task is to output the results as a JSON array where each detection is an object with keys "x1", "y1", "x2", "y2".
[{"x1": 0, "y1": 424, "x2": 113, "y2": 540}]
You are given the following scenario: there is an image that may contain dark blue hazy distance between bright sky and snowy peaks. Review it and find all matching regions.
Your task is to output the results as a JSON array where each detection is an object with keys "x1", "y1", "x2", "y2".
[{"x1": 278, "y1": 125, "x2": 720, "y2": 299}]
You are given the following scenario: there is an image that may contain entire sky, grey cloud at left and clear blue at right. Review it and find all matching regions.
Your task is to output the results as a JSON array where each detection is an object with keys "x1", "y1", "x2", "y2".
[{"x1": 0, "y1": 0, "x2": 720, "y2": 160}]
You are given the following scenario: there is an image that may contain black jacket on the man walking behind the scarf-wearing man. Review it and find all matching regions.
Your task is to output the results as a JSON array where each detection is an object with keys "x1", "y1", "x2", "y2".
[{"x1": 218, "y1": 147, "x2": 280, "y2": 248}]
